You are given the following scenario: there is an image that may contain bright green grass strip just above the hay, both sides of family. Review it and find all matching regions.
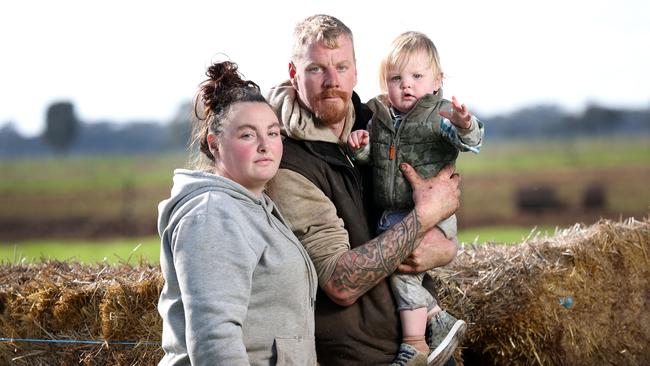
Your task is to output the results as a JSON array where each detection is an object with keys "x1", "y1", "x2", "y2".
[{"x1": 0, "y1": 226, "x2": 555, "y2": 264}]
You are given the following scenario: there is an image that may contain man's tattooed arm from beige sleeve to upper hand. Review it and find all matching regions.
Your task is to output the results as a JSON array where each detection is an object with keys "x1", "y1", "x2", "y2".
[{"x1": 268, "y1": 164, "x2": 459, "y2": 306}]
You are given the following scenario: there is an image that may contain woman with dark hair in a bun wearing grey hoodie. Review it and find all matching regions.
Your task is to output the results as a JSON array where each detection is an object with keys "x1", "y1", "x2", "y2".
[{"x1": 158, "y1": 62, "x2": 317, "y2": 365}]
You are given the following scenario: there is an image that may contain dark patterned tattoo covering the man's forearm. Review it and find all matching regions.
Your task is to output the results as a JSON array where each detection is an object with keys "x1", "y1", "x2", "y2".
[{"x1": 331, "y1": 210, "x2": 422, "y2": 300}]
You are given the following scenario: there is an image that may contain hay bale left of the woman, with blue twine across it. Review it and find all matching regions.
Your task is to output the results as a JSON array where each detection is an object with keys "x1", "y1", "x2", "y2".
[{"x1": 0, "y1": 261, "x2": 163, "y2": 365}]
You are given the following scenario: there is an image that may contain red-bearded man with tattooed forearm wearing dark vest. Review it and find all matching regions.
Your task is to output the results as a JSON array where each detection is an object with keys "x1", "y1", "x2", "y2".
[{"x1": 267, "y1": 15, "x2": 460, "y2": 366}]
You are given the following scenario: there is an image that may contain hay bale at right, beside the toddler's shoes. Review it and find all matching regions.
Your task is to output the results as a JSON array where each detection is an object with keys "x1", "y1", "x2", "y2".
[{"x1": 435, "y1": 219, "x2": 650, "y2": 365}]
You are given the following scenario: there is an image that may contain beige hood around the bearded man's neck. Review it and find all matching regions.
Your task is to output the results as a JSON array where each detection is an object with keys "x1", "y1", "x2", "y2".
[{"x1": 266, "y1": 80, "x2": 354, "y2": 144}]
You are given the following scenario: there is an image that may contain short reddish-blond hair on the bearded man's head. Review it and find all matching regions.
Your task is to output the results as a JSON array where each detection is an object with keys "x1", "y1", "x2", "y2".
[{"x1": 291, "y1": 14, "x2": 354, "y2": 62}]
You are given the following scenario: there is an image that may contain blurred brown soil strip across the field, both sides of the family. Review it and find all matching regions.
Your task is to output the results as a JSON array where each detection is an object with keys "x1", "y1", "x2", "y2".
[{"x1": 0, "y1": 166, "x2": 650, "y2": 243}]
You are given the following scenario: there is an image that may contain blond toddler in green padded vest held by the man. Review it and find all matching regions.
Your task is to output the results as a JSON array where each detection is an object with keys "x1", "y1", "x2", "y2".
[{"x1": 348, "y1": 32, "x2": 483, "y2": 366}]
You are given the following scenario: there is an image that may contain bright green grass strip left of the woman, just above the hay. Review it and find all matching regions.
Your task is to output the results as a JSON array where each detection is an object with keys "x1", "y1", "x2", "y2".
[{"x1": 0, "y1": 236, "x2": 160, "y2": 264}]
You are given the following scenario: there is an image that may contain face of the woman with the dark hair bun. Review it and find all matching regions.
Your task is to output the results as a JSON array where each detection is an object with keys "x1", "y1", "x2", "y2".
[{"x1": 208, "y1": 102, "x2": 282, "y2": 196}]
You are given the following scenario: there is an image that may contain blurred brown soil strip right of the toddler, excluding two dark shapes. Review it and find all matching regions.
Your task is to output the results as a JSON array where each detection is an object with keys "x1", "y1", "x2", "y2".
[{"x1": 457, "y1": 166, "x2": 650, "y2": 228}]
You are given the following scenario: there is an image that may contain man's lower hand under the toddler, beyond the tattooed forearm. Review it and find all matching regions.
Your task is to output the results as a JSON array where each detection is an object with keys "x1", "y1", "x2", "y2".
[{"x1": 397, "y1": 227, "x2": 458, "y2": 273}]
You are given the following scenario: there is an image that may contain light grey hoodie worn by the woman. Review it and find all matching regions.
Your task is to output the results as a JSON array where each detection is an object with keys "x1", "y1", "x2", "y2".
[{"x1": 158, "y1": 169, "x2": 317, "y2": 365}]
